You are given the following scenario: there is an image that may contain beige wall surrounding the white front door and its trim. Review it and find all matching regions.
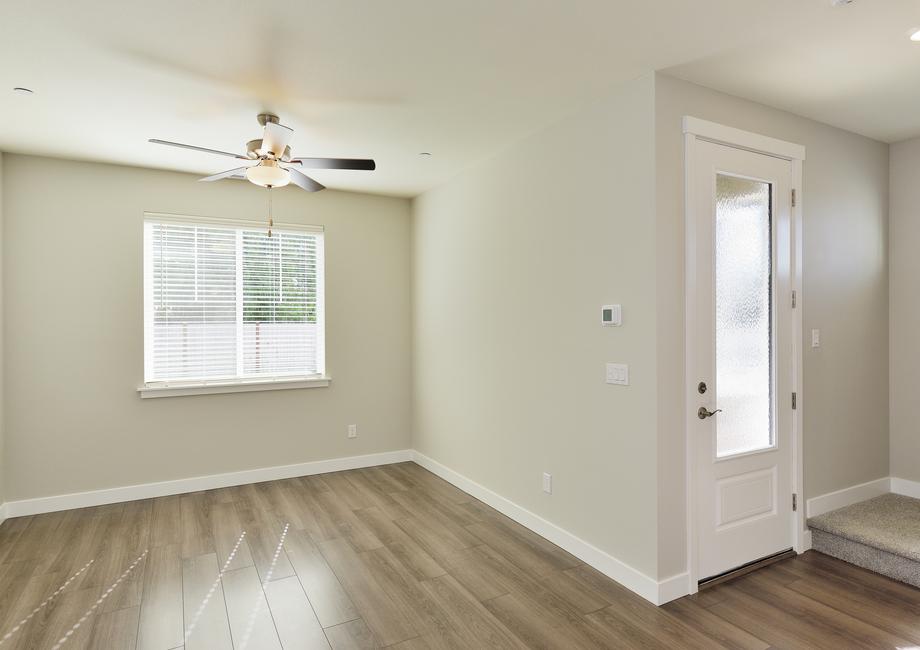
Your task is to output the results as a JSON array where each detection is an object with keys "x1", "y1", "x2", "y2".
[{"x1": 655, "y1": 75, "x2": 889, "y2": 576}]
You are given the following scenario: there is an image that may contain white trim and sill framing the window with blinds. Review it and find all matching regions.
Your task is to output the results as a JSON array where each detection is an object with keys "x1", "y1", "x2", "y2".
[{"x1": 137, "y1": 212, "x2": 332, "y2": 399}]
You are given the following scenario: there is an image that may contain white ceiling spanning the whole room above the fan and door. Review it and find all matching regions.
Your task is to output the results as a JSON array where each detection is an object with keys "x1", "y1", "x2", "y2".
[{"x1": 0, "y1": 0, "x2": 920, "y2": 196}]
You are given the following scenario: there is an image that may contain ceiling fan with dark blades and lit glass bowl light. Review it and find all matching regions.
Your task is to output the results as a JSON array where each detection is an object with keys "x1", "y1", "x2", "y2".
[{"x1": 149, "y1": 113, "x2": 377, "y2": 192}]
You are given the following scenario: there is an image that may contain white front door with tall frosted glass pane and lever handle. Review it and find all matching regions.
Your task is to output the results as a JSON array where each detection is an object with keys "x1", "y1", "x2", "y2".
[{"x1": 688, "y1": 141, "x2": 795, "y2": 580}]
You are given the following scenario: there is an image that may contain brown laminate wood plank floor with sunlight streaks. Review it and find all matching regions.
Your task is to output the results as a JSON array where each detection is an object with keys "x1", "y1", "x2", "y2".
[{"x1": 0, "y1": 463, "x2": 920, "y2": 650}]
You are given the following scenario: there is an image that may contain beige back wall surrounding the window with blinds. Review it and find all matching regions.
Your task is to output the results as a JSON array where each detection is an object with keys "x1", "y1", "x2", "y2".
[{"x1": 2, "y1": 154, "x2": 411, "y2": 501}]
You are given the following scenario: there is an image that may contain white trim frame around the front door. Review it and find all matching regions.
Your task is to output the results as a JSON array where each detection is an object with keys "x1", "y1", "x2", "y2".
[{"x1": 683, "y1": 116, "x2": 806, "y2": 594}]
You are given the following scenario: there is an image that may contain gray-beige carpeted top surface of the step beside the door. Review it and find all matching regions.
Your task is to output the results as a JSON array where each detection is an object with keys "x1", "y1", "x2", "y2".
[{"x1": 808, "y1": 494, "x2": 920, "y2": 560}]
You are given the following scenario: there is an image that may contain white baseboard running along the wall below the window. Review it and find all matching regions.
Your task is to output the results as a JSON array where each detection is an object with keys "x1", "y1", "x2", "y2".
[{"x1": 0, "y1": 449, "x2": 412, "y2": 522}]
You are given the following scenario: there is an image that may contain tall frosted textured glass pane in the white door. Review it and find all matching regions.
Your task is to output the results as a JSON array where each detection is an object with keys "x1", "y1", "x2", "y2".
[{"x1": 715, "y1": 174, "x2": 775, "y2": 458}]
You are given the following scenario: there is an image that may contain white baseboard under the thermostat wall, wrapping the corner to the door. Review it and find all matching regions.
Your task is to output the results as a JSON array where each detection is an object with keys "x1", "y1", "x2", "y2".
[{"x1": 412, "y1": 451, "x2": 690, "y2": 605}]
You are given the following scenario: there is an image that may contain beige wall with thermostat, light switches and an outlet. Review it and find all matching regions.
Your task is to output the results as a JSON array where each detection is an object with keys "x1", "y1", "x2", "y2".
[{"x1": 413, "y1": 77, "x2": 656, "y2": 576}]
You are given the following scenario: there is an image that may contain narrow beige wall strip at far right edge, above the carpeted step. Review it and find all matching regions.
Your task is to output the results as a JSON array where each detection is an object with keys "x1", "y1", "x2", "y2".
[{"x1": 889, "y1": 138, "x2": 920, "y2": 481}]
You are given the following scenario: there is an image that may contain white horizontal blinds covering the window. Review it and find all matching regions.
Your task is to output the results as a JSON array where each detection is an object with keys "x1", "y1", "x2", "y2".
[{"x1": 144, "y1": 216, "x2": 325, "y2": 385}]
